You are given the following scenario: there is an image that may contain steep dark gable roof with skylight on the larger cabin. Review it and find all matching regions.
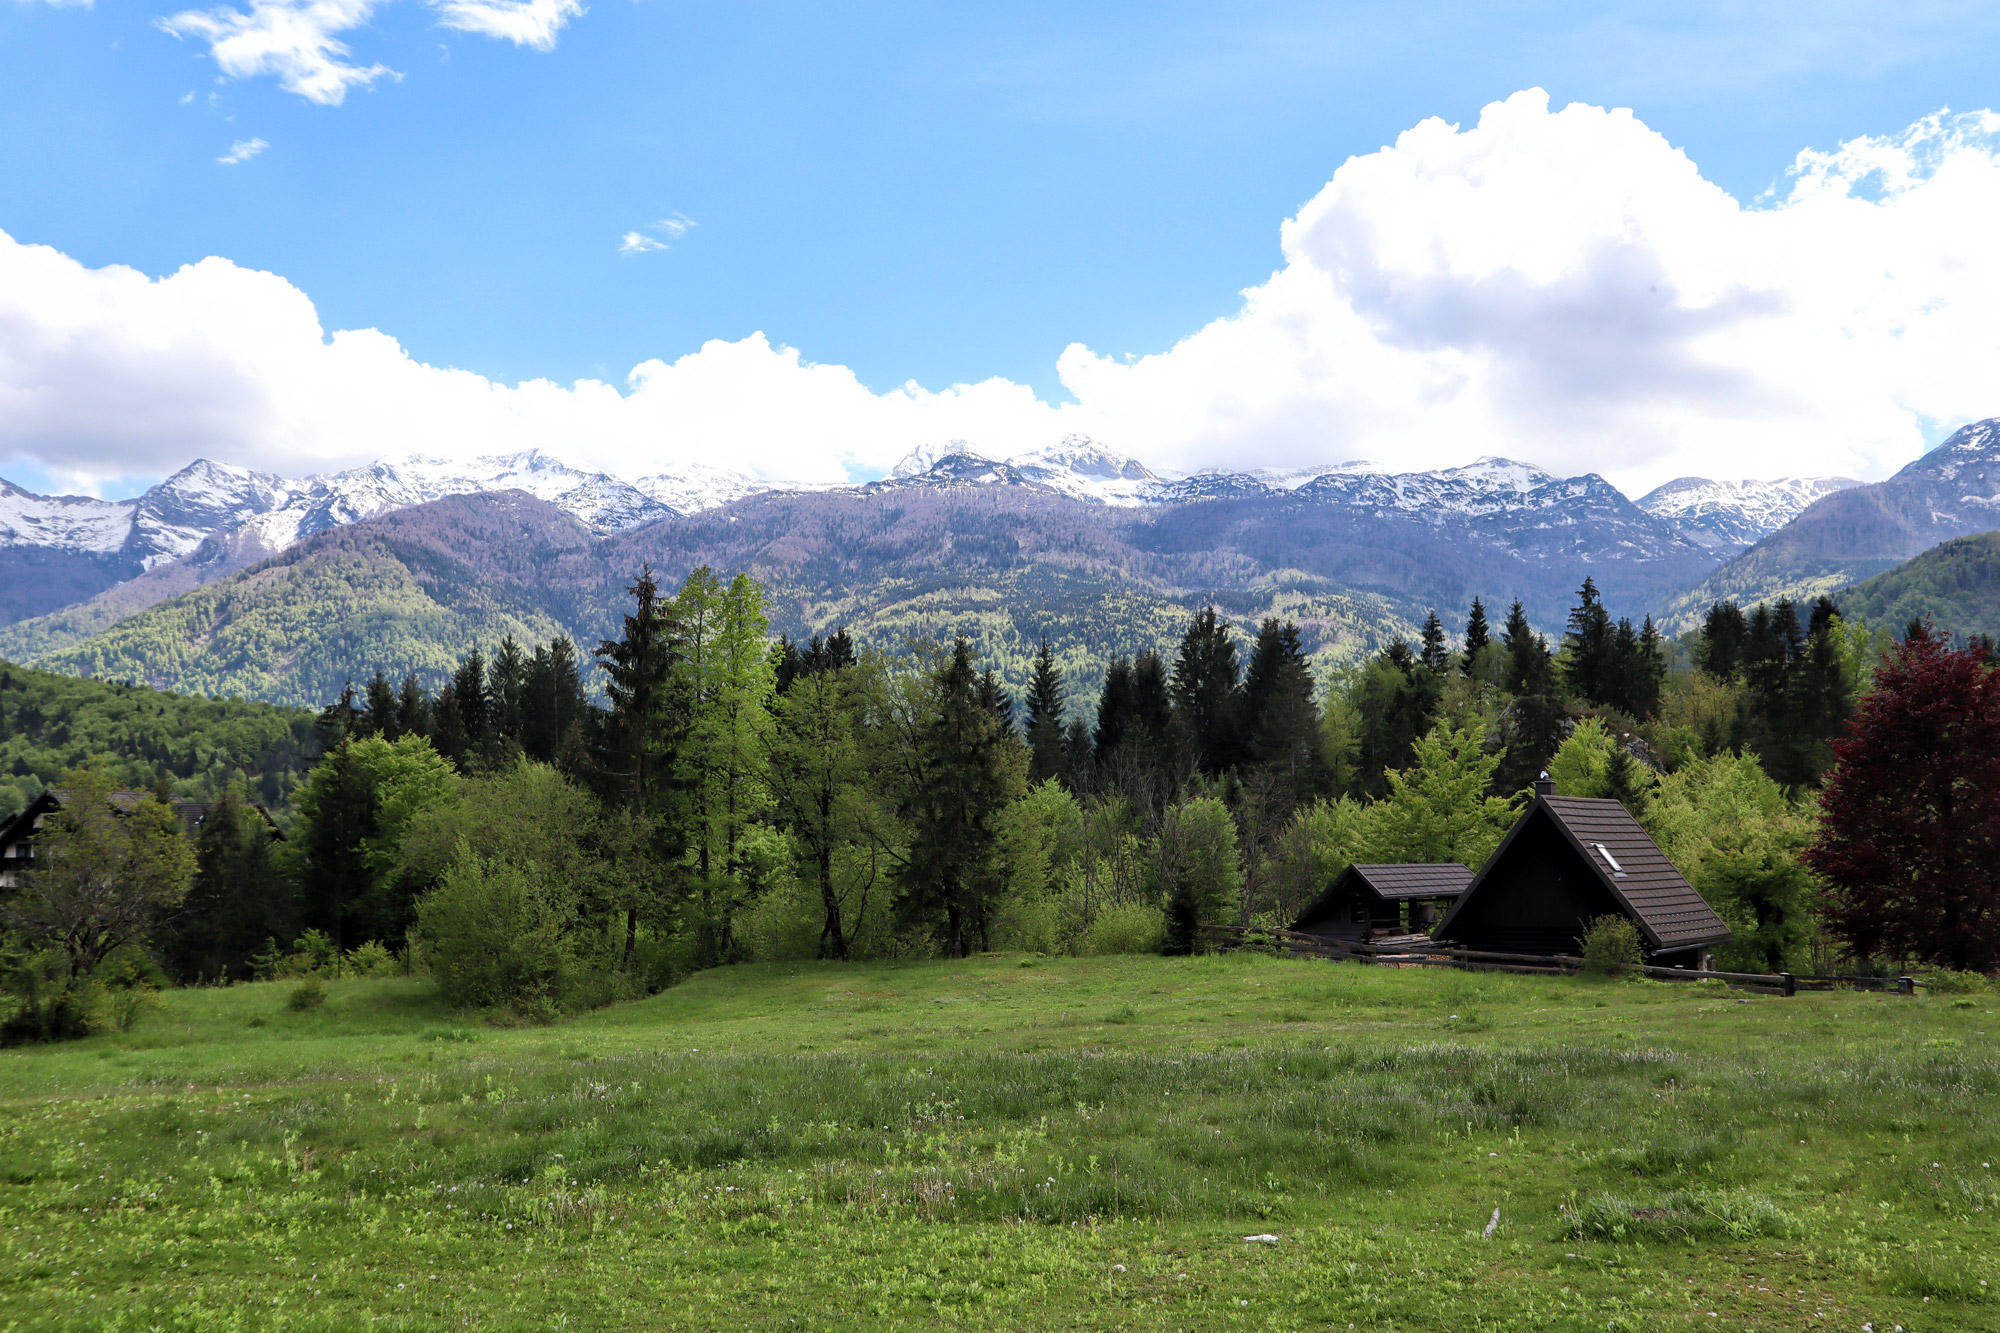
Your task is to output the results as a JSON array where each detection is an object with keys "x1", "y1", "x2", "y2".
[{"x1": 1436, "y1": 797, "x2": 1730, "y2": 953}]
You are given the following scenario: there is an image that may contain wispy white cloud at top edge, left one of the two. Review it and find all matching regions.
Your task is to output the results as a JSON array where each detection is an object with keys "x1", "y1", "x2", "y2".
[{"x1": 160, "y1": 0, "x2": 402, "y2": 106}]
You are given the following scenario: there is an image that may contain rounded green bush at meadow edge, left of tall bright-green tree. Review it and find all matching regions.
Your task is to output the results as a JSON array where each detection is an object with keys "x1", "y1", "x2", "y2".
[{"x1": 416, "y1": 843, "x2": 576, "y2": 1015}]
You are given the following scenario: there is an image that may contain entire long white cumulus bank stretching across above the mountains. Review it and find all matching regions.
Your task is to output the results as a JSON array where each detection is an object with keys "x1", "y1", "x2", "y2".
[{"x1": 11, "y1": 92, "x2": 2000, "y2": 492}]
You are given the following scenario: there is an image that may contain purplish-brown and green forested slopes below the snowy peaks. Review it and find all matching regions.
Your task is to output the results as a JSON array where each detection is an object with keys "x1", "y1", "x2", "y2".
[{"x1": 11, "y1": 474, "x2": 1708, "y2": 705}]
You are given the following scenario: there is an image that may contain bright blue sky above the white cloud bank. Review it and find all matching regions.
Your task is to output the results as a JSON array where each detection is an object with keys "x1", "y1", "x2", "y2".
[{"x1": 0, "y1": 0, "x2": 2000, "y2": 496}]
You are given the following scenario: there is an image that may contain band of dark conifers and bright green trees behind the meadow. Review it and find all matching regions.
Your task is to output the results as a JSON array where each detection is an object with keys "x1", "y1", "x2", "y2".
[{"x1": 0, "y1": 548, "x2": 1992, "y2": 1033}]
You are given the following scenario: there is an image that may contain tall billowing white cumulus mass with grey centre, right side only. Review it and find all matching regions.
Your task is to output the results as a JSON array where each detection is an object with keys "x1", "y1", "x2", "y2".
[{"x1": 1060, "y1": 90, "x2": 2000, "y2": 486}]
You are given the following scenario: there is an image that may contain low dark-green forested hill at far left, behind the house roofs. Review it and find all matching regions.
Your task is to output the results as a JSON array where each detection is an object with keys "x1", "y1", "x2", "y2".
[{"x1": 0, "y1": 662, "x2": 318, "y2": 817}]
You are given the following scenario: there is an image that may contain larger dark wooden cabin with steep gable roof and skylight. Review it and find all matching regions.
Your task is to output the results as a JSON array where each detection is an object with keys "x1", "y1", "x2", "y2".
[{"x1": 1434, "y1": 781, "x2": 1730, "y2": 967}]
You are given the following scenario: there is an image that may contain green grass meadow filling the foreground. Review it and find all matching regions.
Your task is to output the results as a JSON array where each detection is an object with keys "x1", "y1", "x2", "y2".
[{"x1": 0, "y1": 957, "x2": 2000, "y2": 1333}]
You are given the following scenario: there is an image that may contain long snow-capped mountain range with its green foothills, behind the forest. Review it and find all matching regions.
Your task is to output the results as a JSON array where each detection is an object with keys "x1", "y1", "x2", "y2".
[{"x1": 0, "y1": 436, "x2": 1888, "y2": 703}]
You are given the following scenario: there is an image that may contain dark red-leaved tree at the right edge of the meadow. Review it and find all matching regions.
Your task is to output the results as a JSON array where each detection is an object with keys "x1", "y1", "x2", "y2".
[{"x1": 1806, "y1": 626, "x2": 2000, "y2": 973}]
